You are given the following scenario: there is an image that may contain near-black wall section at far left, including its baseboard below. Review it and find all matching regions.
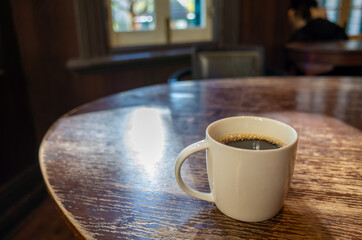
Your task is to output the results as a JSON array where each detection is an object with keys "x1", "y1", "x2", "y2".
[{"x1": 0, "y1": 1, "x2": 46, "y2": 235}]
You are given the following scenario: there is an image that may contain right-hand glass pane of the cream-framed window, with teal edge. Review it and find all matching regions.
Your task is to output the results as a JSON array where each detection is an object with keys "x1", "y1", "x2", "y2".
[{"x1": 170, "y1": 0, "x2": 205, "y2": 29}]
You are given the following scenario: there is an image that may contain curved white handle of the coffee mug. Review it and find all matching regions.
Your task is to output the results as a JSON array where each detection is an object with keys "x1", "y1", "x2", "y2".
[{"x1": 175, "y1": 140, "x2": 214, "y2": 202}]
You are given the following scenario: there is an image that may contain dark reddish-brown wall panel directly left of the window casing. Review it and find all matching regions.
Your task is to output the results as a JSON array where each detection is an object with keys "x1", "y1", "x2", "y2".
[{"x1": 11, "y1": 0, "x2": 78, "y2": 143}]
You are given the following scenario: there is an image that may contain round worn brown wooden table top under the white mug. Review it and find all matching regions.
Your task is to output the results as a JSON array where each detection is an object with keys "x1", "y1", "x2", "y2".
[{"x1": 40, "y1": 77, "x2": 362, "y2": 239}]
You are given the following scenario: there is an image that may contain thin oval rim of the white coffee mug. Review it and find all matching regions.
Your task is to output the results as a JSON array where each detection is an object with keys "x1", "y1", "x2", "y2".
[{"x1": 206, "y1": 115, "x2": 299, "y2": 153}]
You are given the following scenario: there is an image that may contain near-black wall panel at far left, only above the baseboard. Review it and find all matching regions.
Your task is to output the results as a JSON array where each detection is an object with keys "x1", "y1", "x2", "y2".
[{"x1": 0, "y1": 1, "x2": 37, "y2": 186}]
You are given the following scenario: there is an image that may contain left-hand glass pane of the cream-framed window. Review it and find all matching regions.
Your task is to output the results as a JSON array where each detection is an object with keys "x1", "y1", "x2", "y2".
[{"x1": 111, "y1": 0, "x2": 156, "y2": 32}]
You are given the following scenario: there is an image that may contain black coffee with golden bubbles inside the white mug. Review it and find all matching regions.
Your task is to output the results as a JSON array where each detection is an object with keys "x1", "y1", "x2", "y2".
[{"x1": 219, "y1": 133, "x2": 285, "y2": 150}]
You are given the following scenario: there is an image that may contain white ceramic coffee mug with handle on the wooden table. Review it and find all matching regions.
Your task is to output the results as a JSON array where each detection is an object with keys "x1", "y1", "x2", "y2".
[{"x1": 175, "y1": 116, "x2": 298, "y2": 222}]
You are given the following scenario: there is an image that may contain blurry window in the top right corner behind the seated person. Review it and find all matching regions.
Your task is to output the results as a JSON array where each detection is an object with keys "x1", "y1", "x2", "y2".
[{"x1": 318, "y1": 0, "x2": 362, "y2": 36}]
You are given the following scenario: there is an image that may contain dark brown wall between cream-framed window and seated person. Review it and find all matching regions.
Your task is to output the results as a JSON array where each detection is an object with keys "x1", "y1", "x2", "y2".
[{"x1": 220, "y1": 0, "x2": 290, "y2": 71}]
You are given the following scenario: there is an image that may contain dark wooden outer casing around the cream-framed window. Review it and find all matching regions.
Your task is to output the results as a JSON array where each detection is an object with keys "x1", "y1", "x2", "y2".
[{"x1": 68, "y1": 0, "x2": 218, "y2": 59}]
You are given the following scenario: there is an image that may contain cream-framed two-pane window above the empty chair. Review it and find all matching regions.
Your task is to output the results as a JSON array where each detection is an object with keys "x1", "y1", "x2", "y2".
[{"x1": 107, "y1": 0, "x2": 213, "y2": 47}]
